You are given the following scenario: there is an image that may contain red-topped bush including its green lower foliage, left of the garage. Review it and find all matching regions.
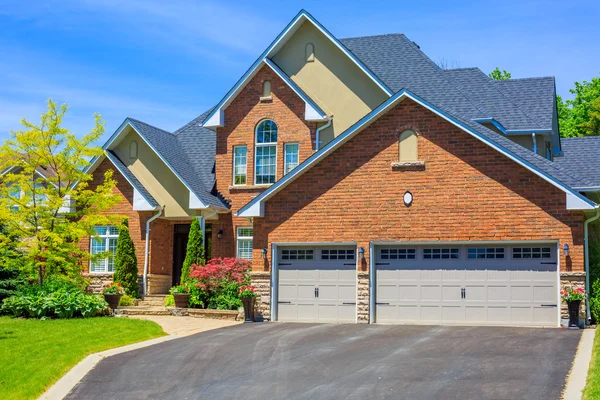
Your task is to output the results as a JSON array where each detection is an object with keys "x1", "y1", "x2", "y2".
[{"x1": 190, "y1": 258, "x2": 250, "y2": 310}]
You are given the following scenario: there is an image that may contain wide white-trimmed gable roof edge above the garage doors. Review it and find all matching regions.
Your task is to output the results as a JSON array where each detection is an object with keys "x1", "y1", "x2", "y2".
[{"x1": 236, "y1": 90, "x2": 596, "y2": 217}]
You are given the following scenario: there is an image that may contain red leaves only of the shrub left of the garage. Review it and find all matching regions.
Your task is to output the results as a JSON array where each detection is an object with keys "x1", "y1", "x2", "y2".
[{"x1": 190, "y1": 258, "x2": 251, "y2": 291}]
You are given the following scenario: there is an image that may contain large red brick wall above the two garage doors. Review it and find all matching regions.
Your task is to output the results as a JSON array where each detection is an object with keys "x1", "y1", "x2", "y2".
[{"x1": 253, "y1": 100, "x2": 583, "y2": 271}]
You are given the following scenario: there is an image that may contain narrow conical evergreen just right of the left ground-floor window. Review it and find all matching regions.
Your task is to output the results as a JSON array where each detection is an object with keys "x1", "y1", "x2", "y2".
[{"x1": 113, "y1": 218, "x2": 140, "y2": 299}]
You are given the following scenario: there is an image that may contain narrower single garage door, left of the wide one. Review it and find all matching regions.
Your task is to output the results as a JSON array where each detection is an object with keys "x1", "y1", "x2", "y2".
[{"x1": 277, "y1": 246, "x2": 357, "y2": 322}]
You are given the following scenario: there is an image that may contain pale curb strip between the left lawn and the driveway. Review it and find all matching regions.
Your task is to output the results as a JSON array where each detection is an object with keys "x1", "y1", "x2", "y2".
[{"x1": 39, "y1": 335, "x2": 176, "y2": 400}]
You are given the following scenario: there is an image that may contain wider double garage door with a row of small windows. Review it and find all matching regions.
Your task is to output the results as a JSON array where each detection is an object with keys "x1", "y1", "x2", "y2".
[{"x1": 375, "y1": 244, "x2": 559, "y2": 326}]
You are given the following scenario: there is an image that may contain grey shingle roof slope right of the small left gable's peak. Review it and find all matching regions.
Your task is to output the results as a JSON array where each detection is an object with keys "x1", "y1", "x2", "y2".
[{"x1": 129, "y1": 118, "x2": 226, "y2": 207}]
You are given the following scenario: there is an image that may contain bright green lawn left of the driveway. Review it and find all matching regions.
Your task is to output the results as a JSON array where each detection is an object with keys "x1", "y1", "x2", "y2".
[{"x1": 0, "y1": 317, "x2": 165, "y2": 400}]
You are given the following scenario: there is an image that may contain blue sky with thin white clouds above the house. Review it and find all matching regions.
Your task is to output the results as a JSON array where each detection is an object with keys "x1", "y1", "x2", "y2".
[{"x1": 0, "y1": 0, "x2": 600, "y2": 139}]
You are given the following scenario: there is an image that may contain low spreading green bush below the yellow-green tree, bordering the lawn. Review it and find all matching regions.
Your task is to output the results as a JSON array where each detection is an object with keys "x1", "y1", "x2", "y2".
[{"x1": 2, "y1": 282, "x2": 108, "y2": 318}]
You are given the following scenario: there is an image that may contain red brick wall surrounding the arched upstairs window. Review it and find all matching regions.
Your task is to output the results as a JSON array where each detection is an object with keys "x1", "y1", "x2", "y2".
[{"x1": 212, "y1": 67, "x2": 316, "y2": 257}]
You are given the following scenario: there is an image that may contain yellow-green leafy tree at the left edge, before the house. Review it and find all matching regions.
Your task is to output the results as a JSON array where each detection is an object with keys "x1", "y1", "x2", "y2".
[{"x1": 0, "y1": 100, "x2": 119, "y2": 284}]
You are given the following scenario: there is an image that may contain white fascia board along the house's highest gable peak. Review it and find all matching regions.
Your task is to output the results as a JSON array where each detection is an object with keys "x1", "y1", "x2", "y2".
[{"x1": 202, "y1": 10, "x2": 393, "y2": 128}]
